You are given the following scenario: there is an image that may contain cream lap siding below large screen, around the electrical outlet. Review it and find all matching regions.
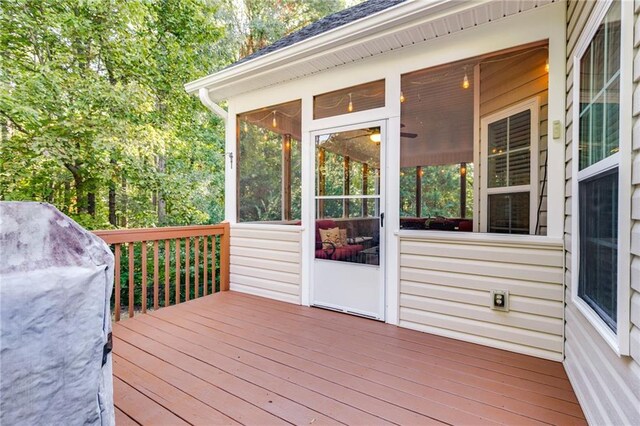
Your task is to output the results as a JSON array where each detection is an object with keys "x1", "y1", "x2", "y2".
[{"x1": 400, "y1": 237, "x2": 563, "y2": 360}]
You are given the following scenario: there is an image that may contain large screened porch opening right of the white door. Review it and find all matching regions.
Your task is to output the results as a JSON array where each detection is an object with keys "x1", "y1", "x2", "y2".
[{"x1": 400, "y1": 42, "x2": 548, "y2": 234}]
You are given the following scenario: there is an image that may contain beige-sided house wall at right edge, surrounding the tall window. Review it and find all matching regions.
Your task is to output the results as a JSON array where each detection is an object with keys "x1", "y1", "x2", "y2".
[{"x1": 564, "y1": 1, "x2": 640, "y2": 424}]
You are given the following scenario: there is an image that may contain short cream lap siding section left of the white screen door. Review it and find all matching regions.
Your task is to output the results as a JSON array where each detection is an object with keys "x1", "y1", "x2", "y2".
[{"x1": 230, "y1": 225, "x2": 301, "y2": 303}]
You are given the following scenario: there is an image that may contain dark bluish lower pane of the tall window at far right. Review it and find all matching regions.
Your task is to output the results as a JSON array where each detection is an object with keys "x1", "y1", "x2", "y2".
[{"x1": 578, "y1": 169, "x2": 618, "y2": 331}]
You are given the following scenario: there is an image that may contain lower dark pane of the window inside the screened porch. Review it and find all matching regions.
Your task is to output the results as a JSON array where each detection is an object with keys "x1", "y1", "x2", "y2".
[{"x1": 488, "y1": 192, "x2": 529, "y2": 234}]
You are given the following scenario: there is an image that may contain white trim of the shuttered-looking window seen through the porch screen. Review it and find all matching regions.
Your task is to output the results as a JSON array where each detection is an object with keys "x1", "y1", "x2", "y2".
[{"x1": 480, "y1": 96, "x2": 540, "y2": 235}]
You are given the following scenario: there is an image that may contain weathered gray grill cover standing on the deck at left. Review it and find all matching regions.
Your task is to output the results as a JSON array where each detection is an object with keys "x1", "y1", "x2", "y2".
[{"x1": 0, "y1": 202, "x2": 115, "y2": 425}]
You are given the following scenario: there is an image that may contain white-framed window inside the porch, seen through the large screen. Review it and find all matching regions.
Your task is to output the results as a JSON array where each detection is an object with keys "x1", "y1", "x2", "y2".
[{"x1": 481, "y1": 103, "x2": 539, "y2": 234}]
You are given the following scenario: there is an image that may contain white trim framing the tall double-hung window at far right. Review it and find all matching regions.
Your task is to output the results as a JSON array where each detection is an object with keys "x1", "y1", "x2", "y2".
[{"x1": 571, "y1": 0, "x2": 634, "y2": 356}]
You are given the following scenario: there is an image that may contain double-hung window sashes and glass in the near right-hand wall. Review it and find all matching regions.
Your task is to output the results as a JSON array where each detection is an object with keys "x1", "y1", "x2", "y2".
[{"x1": 577, "y1": 2, "x2": 621, "y2": 333}]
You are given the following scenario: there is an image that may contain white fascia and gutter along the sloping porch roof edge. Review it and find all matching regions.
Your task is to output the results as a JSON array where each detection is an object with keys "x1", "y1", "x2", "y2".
[{"x1": 185, "y1": 0, "x2": 482, "y2": 97}]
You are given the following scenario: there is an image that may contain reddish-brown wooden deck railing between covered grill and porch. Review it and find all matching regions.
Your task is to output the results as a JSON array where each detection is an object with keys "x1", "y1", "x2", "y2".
[{"x1": 94, "y1": 223, "x2": 229, "y2": 321}]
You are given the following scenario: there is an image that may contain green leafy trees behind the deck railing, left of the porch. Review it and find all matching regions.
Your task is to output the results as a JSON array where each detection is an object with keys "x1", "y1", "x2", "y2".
[{"x1": 0, "y1": 0, "x2": 358, "y2": 229}]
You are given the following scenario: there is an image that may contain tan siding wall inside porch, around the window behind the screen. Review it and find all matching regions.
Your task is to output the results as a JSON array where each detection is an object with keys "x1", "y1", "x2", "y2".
[{"x1": 476, "y1": 47, "x2": 549, "y2": 235}]
